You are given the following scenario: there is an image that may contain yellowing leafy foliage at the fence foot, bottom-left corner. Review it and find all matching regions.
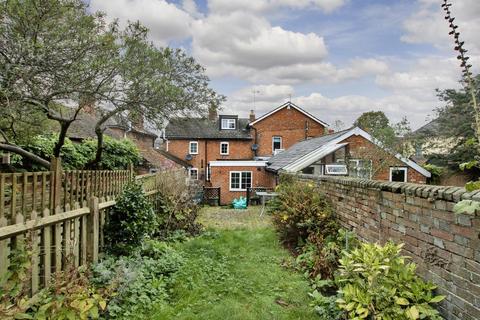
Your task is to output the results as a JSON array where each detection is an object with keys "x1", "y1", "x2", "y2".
[{"x1": 0, "y1": 244, "x2": 110, "y2": 320}]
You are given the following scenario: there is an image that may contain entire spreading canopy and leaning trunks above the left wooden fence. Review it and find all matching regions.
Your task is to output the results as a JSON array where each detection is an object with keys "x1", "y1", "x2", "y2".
[{"x1": 0, "y1": 0, "x2": 224, "y2": 167}]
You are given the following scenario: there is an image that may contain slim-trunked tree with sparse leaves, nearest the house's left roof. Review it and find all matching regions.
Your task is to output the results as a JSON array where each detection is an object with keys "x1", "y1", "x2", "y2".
[{"x1": 90, "y1": 22, "x2": 225, "y2": 166}]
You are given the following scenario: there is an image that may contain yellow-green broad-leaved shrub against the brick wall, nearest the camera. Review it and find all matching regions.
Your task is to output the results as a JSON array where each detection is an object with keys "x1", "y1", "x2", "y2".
[{"x1": 336, "y1": 242, "x2": 444, "y2": 320}]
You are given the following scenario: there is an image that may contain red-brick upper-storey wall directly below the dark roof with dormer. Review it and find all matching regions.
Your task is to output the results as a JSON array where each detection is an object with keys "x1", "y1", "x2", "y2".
[{"x1": 168, "y1": 139, "x2": 253, "y2": 181}]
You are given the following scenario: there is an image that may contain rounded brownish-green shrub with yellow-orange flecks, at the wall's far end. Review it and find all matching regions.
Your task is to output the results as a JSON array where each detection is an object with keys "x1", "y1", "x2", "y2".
[{"x1": 270, "y1": 181, "x2": 337, "y2": 246}]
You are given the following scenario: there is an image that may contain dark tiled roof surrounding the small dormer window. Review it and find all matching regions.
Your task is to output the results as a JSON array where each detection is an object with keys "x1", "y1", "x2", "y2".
[{"x1": 165, "y1": 118, "x2": 252, "y2": 140}]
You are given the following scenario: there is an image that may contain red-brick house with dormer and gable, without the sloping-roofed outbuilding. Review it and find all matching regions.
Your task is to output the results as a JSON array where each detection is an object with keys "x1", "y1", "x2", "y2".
[{"x1": 165, "y1": 102, "x2": 328, "y2": 204}]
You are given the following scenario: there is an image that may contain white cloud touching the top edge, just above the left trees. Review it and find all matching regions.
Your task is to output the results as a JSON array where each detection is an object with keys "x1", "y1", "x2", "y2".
[{"x1": 90, "y1": 0, "x2": 193, "y2": 45}]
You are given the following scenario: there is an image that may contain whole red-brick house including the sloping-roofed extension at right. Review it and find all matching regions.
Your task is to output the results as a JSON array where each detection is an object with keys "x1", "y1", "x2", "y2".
[{"x1": 164, "y1": 102, "x2": 430, "y2": 204}]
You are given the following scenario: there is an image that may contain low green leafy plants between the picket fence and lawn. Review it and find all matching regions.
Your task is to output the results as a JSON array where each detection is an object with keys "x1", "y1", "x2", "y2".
[{"x1": 92, "y1": 240, "x2": 184, "y2": 319}]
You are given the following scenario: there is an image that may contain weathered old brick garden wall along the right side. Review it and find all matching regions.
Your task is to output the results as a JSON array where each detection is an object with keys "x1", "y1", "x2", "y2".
[{"x1": 292, "y1": 175, "x2": 480, "y2": 320}]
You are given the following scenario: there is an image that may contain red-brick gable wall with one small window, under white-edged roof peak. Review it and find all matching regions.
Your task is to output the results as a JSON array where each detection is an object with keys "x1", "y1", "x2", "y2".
[{"x1": 252, "y1": 107, "x2": 325, "y2": 157}]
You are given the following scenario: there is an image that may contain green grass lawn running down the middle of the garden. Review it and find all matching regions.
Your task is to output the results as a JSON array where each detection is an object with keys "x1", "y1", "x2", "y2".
[{"x1": 150, "y1": 207, "x2": 318, "y2": 320}]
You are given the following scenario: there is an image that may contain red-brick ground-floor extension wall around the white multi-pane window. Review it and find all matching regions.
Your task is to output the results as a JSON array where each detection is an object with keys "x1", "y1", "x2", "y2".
[{"x1": 210, "y1": 166, "x2": 276, "y2": 205}]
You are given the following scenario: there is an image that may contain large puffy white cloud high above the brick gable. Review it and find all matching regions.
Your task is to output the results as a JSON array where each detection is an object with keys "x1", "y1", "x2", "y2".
[{"x1": 192, "y1": 12, "x2": 327, "y2": 70}]
